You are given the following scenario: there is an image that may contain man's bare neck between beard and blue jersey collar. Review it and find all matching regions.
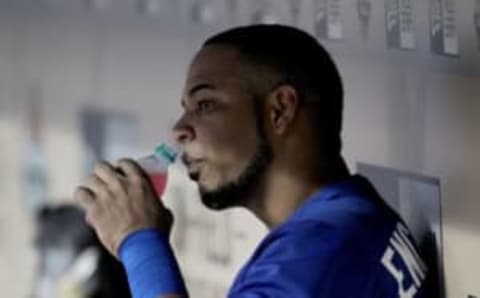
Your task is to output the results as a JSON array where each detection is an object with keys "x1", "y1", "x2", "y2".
[{"x1": 247, "y1": 158, "x2": 350, "y2": 229}]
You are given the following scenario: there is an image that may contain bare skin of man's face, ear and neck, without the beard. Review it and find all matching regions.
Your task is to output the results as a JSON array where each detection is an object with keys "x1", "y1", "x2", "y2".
[{"x1": 174, "y1": 45, "x2": 348, "y2": 228}]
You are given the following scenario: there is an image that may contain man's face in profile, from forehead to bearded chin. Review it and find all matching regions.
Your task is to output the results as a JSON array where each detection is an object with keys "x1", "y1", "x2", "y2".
[{"x1": 174, "y1": 45, "x2": 271, "y2": 209}]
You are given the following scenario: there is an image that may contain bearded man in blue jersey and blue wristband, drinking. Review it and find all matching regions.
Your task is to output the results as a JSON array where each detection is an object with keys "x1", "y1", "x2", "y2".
[{"x1": 76, "y1": 25, "x2": 427, "y2": 298}]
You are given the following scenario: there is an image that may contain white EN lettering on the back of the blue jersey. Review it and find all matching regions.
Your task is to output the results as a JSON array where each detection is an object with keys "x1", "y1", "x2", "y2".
[{"x1": 382, "y1": 222, "x2": 427, "y2": 298}]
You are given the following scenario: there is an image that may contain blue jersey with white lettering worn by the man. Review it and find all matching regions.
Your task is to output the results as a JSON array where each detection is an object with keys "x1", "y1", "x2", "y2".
[{"x1": 229, "y1": 176, "x2": 428, "y2": 298}]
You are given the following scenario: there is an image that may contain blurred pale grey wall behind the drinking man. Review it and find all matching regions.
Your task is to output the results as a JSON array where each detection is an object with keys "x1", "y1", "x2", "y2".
[{"x1": 0, "y1": 0, "x2": 480, "y2": 298}]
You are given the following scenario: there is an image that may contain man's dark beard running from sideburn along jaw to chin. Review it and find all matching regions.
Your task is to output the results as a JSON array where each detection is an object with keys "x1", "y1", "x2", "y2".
[{"x1": 200, "y1": 99, "x2": 273, "y2": 210}]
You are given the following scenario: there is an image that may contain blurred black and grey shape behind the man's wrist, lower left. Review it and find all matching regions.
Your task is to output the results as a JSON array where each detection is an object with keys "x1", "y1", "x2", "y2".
[{"x1": 31, "y1": 204, "x2": 131, "y2": 298}]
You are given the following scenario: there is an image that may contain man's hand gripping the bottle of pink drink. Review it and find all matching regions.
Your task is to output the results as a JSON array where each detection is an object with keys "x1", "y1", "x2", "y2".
[{"x1": 74, "y1": 159, "x2": 173, "y2": 256}]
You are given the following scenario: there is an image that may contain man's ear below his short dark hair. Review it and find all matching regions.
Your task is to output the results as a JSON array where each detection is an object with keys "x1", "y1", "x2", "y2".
[{"x1": 267, "y1": 85, "x2": 299, "y2": 135}]
